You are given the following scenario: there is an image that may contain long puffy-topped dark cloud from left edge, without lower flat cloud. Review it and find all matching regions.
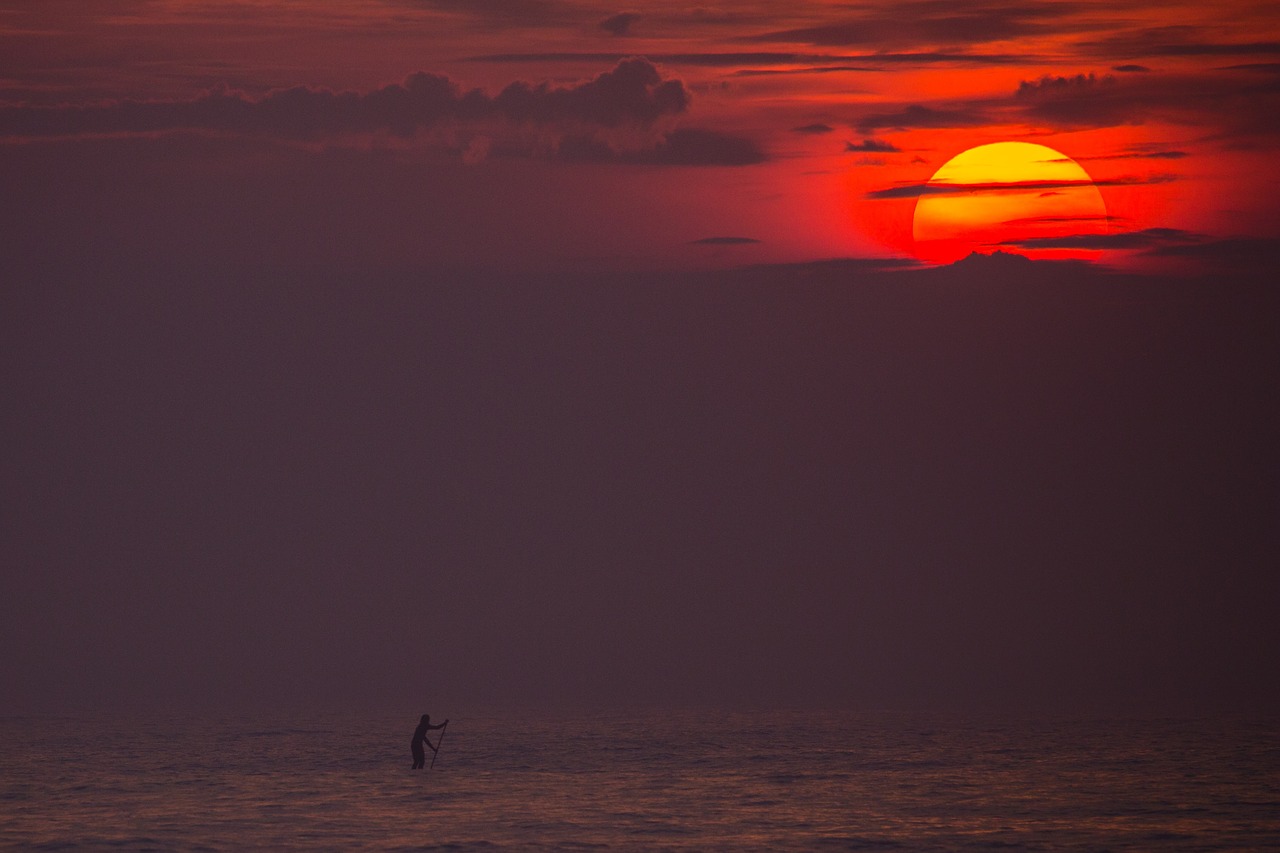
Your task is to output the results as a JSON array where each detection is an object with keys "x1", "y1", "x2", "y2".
[{"x1": 0, "y1": 59, "x2": 689, "y2": 140}]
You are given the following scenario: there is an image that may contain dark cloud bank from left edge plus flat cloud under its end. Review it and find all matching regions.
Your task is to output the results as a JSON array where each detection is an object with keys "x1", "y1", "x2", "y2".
[{"x1": 0, "y1": 58, "x2": 767, "y2": 165}]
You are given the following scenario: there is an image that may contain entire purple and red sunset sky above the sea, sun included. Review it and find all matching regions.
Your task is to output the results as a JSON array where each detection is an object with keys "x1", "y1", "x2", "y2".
[{"x1": 0, "y1": 0, "x2": 1280, "y2": 716}]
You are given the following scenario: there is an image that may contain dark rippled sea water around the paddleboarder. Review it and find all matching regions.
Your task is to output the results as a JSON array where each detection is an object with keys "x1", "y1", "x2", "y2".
[{"x1": 0, "y1": 712, "x2": 1280, "y2": 850}]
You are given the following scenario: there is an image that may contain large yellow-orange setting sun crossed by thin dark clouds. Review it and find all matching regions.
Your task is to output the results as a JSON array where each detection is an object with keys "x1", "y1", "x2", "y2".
[{"x1": 911, "y1": 142, "x2": 1108, "y2": 264}]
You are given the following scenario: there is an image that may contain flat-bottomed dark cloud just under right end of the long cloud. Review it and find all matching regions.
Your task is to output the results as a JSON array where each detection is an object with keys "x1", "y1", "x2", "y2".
[{"x1": 558, "y1": 127, "x2": 768, "y2": 167}]
